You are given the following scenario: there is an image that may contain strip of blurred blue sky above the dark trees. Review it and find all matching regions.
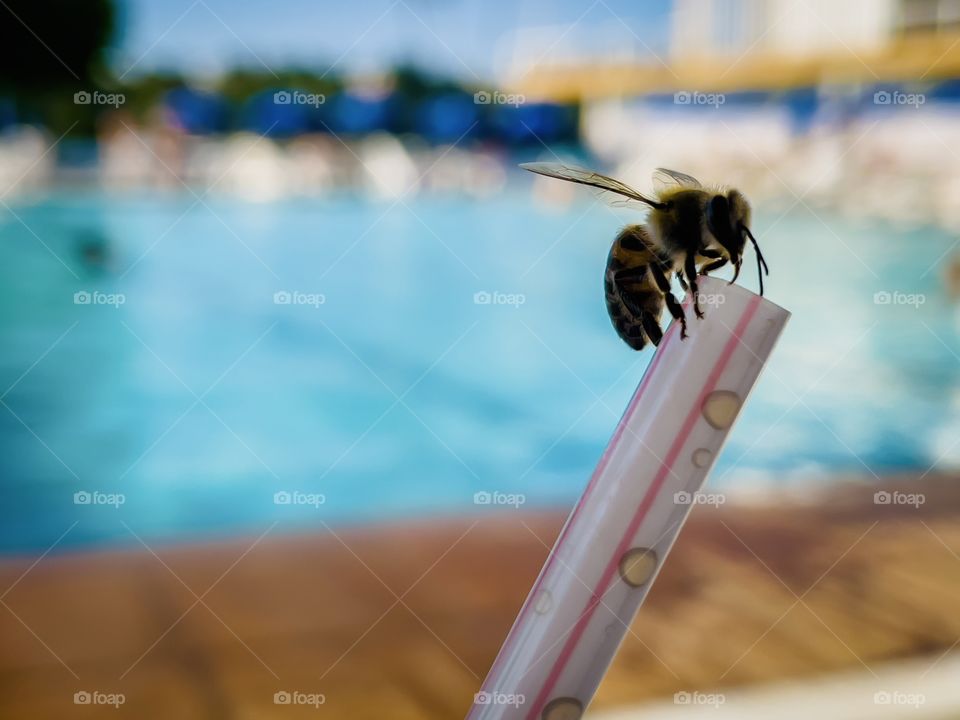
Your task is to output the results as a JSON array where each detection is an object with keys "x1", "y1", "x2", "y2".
[{"x1": 114, "y1": 0, "x2": 670, "y2": 80}]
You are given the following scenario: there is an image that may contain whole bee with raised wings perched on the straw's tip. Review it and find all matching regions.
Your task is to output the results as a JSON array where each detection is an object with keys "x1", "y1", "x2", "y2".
[{"x1": 520, "y1": 163, "x2": 769, "y2": 350}]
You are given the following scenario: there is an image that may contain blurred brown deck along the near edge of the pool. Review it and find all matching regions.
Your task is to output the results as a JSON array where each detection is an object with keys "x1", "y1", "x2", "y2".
[{"x1": 0, "y1": 478, "x2": 960, "y2": 720}]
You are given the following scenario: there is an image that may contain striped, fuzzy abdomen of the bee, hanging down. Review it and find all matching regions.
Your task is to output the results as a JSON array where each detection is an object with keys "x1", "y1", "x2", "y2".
[{"x1": 603, "y1": 225, "x2": 673, "y2": 350}]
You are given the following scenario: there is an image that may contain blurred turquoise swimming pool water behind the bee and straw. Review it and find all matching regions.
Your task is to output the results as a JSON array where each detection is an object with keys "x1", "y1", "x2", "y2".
[{"x1": 0, "y1": 191, "x2": 960, "y2": 553}]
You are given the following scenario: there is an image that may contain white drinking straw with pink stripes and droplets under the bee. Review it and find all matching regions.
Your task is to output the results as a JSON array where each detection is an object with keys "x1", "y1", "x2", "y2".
[{"x1": 468, "y1": 277, "x2": 790, "y2": 720}]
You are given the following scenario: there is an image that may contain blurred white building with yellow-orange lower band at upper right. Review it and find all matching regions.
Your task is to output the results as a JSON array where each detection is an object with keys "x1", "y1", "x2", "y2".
[{"x1": 512, "y1": 0, "x2": 960, "y2": 100}]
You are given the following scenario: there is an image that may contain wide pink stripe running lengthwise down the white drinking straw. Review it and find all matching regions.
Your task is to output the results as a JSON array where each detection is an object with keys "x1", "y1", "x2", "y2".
[{"x1": 527, "y1": 297, "x2": 760, "y2": 720}]
